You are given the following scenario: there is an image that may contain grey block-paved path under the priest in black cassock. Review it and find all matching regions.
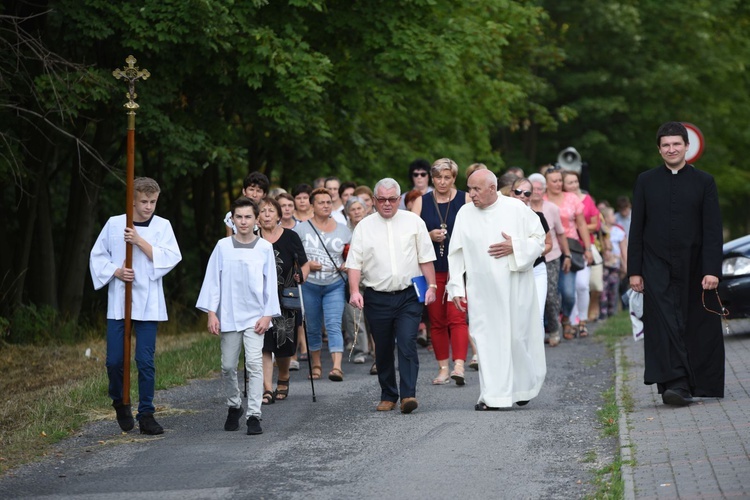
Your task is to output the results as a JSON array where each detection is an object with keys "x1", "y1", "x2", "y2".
[{"x1": 618, "y1": 335, "x2": 750, "y2": 499}]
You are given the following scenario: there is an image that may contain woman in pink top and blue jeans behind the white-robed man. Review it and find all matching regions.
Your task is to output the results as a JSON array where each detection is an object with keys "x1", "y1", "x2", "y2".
[{"x1": 544, "y1": 166, "x2": 592, "y2": 340}]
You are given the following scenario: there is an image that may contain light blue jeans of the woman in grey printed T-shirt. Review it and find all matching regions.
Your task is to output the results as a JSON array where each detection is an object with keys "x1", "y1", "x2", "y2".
[{"x1": 302, "y1": 280, "x2": 347, "y2": 353}]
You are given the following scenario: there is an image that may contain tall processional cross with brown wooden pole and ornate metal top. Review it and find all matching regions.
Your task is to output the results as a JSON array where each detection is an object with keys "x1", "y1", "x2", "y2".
[{"x1": 112, "y1": 56, "x2": 151, "y2": 405}]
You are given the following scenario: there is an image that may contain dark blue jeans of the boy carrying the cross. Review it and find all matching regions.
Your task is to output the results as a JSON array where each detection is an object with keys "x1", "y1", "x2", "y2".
[{"x1": 106, "y1": 319, "x2": 157, "y2": 417}]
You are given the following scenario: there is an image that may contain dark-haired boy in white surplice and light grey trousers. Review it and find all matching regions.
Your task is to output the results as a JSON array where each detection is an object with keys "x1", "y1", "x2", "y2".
[{"x1": 196, "y1": 196, "x2": 281, "y2": 435}]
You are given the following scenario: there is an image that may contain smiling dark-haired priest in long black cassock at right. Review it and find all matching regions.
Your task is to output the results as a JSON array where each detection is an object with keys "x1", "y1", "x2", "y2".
[{"x1": 628, "y1": 122, "x2": 724, "y2": 406}]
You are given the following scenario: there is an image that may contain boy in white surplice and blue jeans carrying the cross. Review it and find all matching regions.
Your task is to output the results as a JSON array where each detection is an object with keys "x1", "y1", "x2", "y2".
[{"x1": 89, "y1": 177, "x2": 182, "y2": 434}]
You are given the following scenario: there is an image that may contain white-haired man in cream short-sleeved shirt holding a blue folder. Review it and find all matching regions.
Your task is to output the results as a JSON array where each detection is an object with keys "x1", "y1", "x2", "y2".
[{"x1": 346, "y1": 178, "x2": 437, "y2": 413}]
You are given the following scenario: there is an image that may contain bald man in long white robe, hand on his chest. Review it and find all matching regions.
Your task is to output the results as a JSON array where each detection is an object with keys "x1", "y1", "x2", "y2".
[{"x1": 447, "y1": 170, "x2": 547, "y2": 411}]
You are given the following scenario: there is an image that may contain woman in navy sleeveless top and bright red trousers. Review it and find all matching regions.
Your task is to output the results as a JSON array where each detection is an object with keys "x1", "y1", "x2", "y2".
[{"x1": 411, "y1": 158, "x2": 470, "y2": 385}]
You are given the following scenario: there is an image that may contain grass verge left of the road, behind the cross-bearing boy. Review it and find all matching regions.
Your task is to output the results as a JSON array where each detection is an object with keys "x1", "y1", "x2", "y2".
[{"x1": 0, "y1": 333, "x2": 221, "y2": 474}]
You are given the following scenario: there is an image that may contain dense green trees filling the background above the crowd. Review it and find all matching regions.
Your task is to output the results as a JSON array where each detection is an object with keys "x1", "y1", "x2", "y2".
[{"x1": 0, "y1": 0, "x2": 750, "y2": 336}]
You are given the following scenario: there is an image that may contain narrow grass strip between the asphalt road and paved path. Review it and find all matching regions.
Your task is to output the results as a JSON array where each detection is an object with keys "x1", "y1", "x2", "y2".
[{"x1": 590, "y1": 311, "x2": 632, "y2": 499}]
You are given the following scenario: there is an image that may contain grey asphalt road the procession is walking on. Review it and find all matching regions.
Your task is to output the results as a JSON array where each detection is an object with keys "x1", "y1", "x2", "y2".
[{"x1": 0, "y1": 328, "x2": 617, "y2": 500}]
